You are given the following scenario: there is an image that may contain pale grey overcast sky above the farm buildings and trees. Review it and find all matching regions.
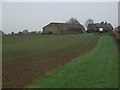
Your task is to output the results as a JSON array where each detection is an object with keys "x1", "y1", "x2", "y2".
[{"x1": 0, "y1": 2, "x2": 118, "y2": 33}]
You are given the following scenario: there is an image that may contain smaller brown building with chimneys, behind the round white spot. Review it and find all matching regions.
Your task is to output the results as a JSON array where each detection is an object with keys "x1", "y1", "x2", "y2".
[{"x1": 87, "y1": 22, "x2": 113, "y2": 32}]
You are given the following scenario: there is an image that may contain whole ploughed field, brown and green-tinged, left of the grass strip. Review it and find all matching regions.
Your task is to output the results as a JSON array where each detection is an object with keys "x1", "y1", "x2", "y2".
[{"x1": 2, "y1": 34, "x2": 99, "y2": 88}]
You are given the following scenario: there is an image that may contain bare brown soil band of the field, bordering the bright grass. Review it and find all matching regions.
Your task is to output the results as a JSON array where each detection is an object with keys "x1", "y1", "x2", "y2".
[{"x1": 2, "y1": 38, "x2": 98, "y2": 88}]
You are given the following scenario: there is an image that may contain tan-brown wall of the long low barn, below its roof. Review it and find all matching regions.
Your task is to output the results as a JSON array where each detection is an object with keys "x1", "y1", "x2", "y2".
[{"x1": 43, "y1": 24, "x2": 83, "y2": 34}]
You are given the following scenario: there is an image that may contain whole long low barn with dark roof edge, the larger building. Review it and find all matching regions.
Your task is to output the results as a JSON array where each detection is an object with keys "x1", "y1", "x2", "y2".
[{"x1": 42, "y1": 22, "x2": 85, "y2": 34}]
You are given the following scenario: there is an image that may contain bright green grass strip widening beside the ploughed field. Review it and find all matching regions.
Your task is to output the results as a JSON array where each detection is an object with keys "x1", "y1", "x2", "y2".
[{"x1": 28, "y1": 35, "x2": 118, "y2": 88}]
